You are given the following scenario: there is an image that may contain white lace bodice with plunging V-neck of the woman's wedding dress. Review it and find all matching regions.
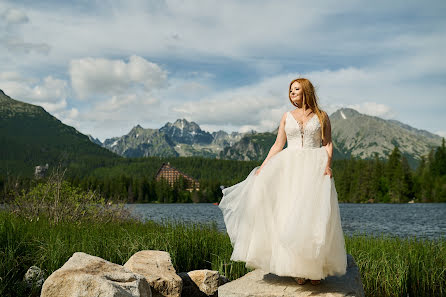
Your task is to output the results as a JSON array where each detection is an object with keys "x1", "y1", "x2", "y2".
[{"x1": 285, "y1": 111, "x2": 322, "y2": 149}]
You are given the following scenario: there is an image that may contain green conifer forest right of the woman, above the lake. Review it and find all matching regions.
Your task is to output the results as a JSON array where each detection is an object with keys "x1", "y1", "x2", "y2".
[{"x1": 333, "y1": 138, "x2": 446, "y2": 203}]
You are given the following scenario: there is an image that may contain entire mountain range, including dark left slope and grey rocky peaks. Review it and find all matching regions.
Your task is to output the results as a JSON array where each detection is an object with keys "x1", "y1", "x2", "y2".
[{"x1": 0, "y1": 90, "x2": 441, "y2": 173}]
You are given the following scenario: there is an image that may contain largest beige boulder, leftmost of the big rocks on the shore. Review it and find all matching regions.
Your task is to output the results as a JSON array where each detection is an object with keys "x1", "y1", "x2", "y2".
[{"x1": 41, "y1": 252, "x2": 152, "y2": 297}]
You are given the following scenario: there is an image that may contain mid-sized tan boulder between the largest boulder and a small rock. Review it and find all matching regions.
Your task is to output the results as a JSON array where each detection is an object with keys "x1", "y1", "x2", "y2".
[{"x1": 124, "y1": 250, "x2": 183, "y2": 297}]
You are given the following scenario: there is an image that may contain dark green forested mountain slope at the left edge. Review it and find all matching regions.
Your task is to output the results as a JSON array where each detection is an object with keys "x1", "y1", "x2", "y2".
[{"x1": 0, "y1": 90, "x2": 121, "y2": 177}]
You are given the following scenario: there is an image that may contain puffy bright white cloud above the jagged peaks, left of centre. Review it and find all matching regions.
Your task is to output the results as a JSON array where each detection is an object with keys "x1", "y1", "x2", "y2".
[{"x1": 69, "y1": 55, "x2": 167, "y2": 99}]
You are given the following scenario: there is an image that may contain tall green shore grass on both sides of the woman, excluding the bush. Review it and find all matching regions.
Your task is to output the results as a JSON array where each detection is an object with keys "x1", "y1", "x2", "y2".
[{"x1": 0, "y1": 211, "x2": 446, "y2": 297}]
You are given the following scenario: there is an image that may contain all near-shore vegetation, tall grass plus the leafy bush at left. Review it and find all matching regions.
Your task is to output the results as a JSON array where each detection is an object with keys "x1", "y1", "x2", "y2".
[{"x1": 0, "y1": 172, "x2": 446, "y2": 297}]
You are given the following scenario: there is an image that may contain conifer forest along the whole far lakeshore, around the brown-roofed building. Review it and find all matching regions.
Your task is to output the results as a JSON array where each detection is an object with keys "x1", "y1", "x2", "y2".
[{"x1": 0, "y1": 139, "x2": 446, "y2": 203}]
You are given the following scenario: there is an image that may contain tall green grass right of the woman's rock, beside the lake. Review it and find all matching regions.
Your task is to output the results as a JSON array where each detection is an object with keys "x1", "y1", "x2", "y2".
[{"x1": 345, "y1": 234, "x2": 446, "y2": 296}]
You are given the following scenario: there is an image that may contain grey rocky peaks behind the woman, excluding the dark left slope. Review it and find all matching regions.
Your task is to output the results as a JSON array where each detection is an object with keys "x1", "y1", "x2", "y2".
[{"x1": 97, "y1": 108, "x2": 441, "y2": 167}]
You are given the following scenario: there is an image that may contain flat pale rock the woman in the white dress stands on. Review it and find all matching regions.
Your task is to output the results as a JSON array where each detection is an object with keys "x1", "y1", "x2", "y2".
[{"x1": 218, "y1": 255, "x2": 364, "y2": 297}]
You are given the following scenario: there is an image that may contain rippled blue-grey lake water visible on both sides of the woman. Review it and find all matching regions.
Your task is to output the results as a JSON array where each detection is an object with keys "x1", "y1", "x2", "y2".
[{"x1": 127, "y1": 203, "x2": 446, "y2": 239}]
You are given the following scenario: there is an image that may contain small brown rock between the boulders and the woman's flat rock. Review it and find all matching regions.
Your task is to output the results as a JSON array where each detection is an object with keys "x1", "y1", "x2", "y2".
[{"x1": 178, "y1": 269, "x2": 227, "y2": 297}]
